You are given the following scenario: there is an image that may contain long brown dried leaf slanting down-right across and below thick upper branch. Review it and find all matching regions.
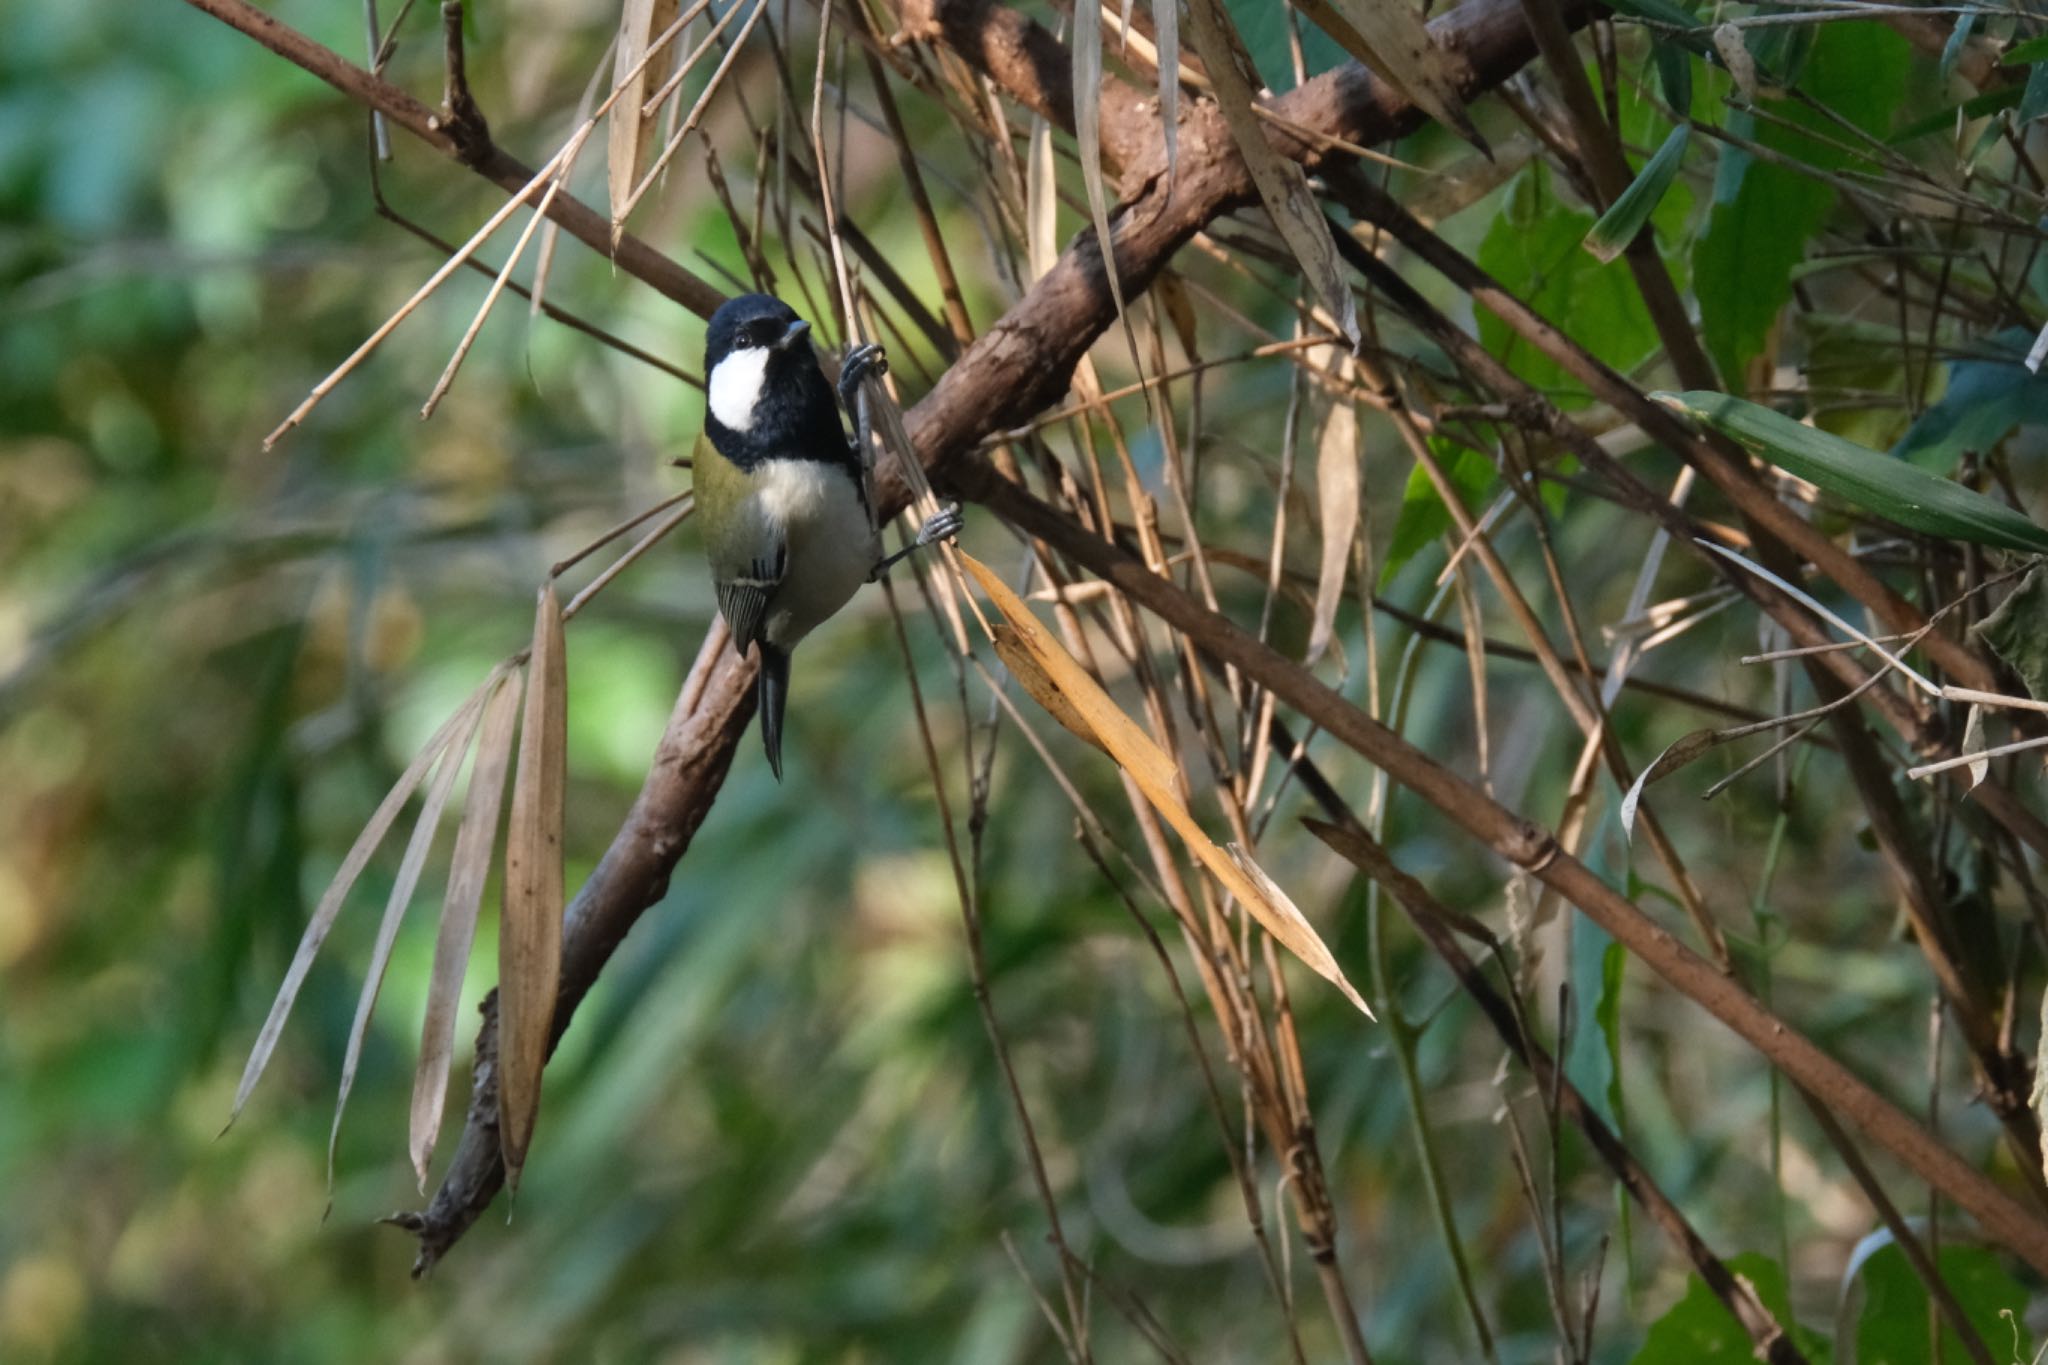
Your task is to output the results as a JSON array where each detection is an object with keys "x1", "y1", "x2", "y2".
[{"x1": 1187, "y1": 0, "x2": 1360, "y2": 350}]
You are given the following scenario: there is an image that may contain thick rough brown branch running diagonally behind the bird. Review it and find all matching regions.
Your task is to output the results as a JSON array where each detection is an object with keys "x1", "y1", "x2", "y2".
[{"x1": 352, "y1": 0, "x2": 1583, "y2": 1273}]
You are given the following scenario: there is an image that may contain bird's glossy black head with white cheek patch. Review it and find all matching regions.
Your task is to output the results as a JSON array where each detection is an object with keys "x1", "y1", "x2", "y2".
[{"x1": 705, "y1": 295, "x2": 850, "y2": 469}]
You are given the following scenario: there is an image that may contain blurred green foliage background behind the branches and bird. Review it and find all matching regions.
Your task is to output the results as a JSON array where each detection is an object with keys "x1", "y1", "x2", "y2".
[{"x1": 0, "y1": 0, "x2": 2039, "y2": 1363}]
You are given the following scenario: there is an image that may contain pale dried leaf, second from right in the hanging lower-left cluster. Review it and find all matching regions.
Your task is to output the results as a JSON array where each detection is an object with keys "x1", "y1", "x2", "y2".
[{"x1": 408, "y1": 671, "x2": 520, "y2": 1193}]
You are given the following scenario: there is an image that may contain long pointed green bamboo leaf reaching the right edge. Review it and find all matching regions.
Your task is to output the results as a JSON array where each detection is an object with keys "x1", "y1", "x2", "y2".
[{"x1": 1653, "y1": 389, "x2": 2048, "y2": 555}]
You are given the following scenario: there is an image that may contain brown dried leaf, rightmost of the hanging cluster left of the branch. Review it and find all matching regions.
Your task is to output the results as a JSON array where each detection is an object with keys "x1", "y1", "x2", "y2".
[{"x1": 498, "y1": 579, "x2": 569, "y2": 1191}]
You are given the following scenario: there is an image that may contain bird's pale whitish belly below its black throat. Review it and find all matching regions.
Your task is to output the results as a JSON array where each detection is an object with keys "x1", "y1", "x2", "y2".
[{"x1": 750, "y1": 460, "x2": 881, "y2": 649}]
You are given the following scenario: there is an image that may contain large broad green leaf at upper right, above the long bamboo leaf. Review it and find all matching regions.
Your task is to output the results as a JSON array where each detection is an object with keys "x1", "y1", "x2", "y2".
[{"x1": 1692, "y1": 23, "x2": 1911, "y2": 385}]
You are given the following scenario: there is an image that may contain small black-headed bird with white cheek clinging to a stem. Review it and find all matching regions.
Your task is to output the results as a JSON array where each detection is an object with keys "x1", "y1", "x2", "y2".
[{"x1": 692, "y1": 295, "x2": 961, "y2": 780}]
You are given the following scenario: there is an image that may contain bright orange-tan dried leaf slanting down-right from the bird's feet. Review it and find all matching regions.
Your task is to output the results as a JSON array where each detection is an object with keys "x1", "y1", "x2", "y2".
[{"x1": 958, "y1": 551, "x2": 1372, "y2": 1019}]
